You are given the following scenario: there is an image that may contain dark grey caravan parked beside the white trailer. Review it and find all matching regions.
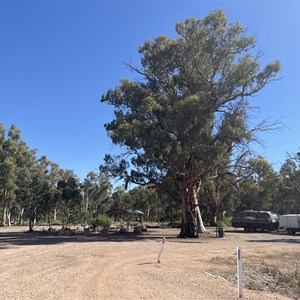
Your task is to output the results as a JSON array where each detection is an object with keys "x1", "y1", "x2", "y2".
[{"x1": 232, "y1": 210, "x2": 279, "y2": 232}]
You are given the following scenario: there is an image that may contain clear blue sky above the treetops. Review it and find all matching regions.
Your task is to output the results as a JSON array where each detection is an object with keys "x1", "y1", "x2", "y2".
[{"x1": 0, "y1": 0, "x2": 300, "y2": 179}]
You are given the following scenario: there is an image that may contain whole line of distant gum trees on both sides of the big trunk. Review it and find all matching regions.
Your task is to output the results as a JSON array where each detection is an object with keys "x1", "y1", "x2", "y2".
[{"x1": 0, "y1": 124, "x2": 300, "y2": 230}]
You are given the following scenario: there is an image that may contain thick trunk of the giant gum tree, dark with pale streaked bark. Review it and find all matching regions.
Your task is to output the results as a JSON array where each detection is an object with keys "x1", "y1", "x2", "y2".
[{"x1": 179, "y1": 186, "x2": 206, "y2": 238}]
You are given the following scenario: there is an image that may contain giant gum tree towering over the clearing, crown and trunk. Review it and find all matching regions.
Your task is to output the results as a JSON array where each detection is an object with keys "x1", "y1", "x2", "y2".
[{"x1": 100, "y1": 10, "x2": 280, "y2": 237}]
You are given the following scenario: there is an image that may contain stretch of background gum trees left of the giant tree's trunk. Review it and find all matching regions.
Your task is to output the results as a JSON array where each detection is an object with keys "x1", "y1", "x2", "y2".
[{"x1": 0, "y1": 124, "x2": 175, "y2": 230}]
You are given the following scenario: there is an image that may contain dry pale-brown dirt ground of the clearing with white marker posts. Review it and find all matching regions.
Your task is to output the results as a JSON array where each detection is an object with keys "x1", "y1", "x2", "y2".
[{"x1": 0, "y1": 227, "x2": 300, "y2": 300}]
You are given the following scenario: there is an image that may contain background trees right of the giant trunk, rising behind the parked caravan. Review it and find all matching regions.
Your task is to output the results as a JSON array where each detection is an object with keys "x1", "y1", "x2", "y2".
[{"x1": 199, "y1": 153, "x2": 300, "y2": 225}]
